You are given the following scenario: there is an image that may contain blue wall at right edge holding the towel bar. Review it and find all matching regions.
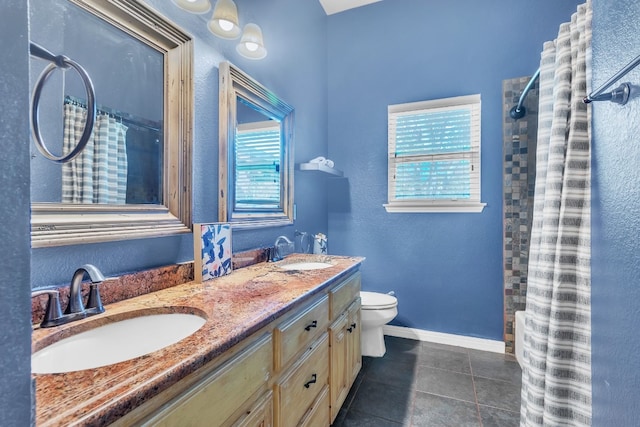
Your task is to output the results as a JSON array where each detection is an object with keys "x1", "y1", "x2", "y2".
[{"x1": 591, "y1": 0, "x2": 640, "y2": 426}]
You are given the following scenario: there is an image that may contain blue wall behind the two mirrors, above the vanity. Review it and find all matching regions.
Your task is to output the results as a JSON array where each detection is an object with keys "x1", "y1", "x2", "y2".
[{"x1": 31, "y1": 0, "x2": 327, "y2": 287}]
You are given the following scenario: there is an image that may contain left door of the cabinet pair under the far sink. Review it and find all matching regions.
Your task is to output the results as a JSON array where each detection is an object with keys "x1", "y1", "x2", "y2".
[{"x1": 329, "y1": 314, "x2": 351, "y2": 422}]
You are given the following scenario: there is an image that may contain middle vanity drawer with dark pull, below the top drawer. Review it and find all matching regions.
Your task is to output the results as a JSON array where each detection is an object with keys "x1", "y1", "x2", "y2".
[{"x1": 275, "y1": 332, "x2": 329, "y2": 427}]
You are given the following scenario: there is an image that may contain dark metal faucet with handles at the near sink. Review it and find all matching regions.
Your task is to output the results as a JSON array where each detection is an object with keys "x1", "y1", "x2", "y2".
[{"x1": 31, "y1": 264, "x2": 104, "y2": 328}]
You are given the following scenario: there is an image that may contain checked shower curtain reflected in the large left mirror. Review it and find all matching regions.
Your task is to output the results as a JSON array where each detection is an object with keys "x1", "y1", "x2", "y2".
[{"x1": 62, "y1": 103, "x2": 127, "y2": 204}]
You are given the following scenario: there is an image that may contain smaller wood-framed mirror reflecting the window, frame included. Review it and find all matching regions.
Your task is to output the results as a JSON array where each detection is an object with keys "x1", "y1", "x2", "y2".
[{"x1": 218, "y1": 62, "x2": 294, "y2": 228}]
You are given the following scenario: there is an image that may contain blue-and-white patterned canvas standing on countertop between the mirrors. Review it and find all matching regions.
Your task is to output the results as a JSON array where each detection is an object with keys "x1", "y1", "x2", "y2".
[{"x1": 198, "y1": 223, "x2": 233, "y2": 283}]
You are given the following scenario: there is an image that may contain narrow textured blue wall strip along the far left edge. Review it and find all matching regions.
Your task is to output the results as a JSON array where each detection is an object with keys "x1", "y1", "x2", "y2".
[{"x1": 0, "y1": 2, "x2": 31, "y2": 426}]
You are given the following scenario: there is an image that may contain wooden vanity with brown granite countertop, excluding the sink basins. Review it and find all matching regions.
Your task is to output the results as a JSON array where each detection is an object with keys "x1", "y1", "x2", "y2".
[{"x1": 34, "y1": 255, "x2": 362, "y2": 426}]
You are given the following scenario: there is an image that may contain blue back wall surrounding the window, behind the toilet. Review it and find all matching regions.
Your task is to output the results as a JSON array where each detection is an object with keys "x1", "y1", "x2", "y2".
[{"x1": 327, "y1": 0, "x2": 581, "y2": 340}]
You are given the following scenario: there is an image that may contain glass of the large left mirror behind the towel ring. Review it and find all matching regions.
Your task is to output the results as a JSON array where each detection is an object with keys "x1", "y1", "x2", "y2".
[{"x1": 31, "y1": 0, "x2": 164, "y2": 205}]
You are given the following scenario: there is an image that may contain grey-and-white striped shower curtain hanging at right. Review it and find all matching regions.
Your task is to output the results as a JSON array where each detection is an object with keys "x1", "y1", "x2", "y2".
[{"x1": 520, "y1": 0, "x2": 591, "y2": 427}]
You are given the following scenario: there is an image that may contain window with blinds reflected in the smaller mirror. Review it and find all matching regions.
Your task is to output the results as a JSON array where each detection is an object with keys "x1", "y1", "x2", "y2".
[{"x1": 234, "y1": 121, "x2": 282, "y2": 210}]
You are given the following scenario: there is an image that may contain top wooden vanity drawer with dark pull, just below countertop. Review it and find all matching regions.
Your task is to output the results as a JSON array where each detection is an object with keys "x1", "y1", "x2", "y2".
[{"x1": 274, "y1": 296, "x2": 329, "y2": 371}]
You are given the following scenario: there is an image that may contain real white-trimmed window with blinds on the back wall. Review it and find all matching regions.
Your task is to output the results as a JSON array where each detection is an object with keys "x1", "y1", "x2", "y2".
[{"x1": 384, "y1": 95, "x2": 485, "y2": 213}]
